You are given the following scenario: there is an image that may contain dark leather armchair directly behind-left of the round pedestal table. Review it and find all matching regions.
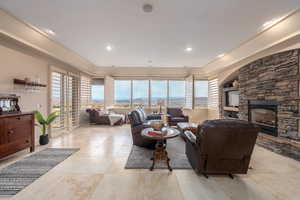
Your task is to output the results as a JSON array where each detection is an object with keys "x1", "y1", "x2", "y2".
[{"x1": 128, "y1": 110, "x2": 156, "y2": 149}]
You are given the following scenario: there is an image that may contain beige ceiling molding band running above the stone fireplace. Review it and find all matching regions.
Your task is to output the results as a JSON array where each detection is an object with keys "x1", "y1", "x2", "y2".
[{"x1": 201, "y1": 9, "x2": 300, "y2": 77}]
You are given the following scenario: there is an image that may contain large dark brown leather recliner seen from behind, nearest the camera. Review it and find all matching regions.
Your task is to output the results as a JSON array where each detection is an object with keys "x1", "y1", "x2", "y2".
[{"x1": 185, "y1": 119, "x2": 259, "y2": 178}]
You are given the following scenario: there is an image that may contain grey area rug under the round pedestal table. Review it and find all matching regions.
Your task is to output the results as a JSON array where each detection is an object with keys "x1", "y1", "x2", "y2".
[{"x1": 125, "y1": 137, "x2": 192, "y2": 169}]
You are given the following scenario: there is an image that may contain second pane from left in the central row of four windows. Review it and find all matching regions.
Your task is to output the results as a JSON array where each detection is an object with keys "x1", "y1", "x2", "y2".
[{"x1": 132, "y1": 80, "x2": 149, "y2": 107}]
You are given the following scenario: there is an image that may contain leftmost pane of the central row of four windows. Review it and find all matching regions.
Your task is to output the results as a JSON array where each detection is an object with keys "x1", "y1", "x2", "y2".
[{"x1": 115, "y1": 80, "x2": 131, "y2": 107}]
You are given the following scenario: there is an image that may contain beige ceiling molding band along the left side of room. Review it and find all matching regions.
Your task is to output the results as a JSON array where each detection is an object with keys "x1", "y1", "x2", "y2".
[{"x1": 0, "y1": 8, "x2": 96, "y2": 74}]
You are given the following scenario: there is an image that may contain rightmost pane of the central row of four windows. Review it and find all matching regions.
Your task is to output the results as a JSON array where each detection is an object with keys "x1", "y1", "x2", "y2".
[{"x1": 168, "y1": 80, "x2": 185, "y2": 107}]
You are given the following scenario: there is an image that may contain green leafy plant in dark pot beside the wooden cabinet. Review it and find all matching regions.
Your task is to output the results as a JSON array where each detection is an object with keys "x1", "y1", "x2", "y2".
[{"x1": 35, "y1": 111, "x2": 58, "y2": 145}]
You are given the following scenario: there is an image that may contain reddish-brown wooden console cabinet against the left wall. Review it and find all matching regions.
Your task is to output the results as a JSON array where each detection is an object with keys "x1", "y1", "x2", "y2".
[{"x1": 0, "y1": 113, "x2": 35, "y2": 158}]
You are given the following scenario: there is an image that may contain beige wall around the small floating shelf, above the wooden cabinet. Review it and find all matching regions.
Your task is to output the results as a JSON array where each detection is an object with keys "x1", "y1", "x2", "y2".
[{"x1": 0, "y1": 45, "x2": 48, "y2": 142}]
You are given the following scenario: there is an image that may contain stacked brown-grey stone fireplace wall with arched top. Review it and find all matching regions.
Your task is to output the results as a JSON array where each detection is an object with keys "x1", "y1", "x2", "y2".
[{"x1": 220, "y1": 49, "x2": 300, "y2": 160}]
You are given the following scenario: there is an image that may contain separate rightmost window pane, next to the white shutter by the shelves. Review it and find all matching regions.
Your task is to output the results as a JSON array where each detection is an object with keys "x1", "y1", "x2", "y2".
[{"x1": 194, "y1": 81, "x2": 208, "y2": 107}]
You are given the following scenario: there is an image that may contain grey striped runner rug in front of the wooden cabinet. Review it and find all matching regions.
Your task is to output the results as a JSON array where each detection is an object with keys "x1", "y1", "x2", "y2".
[{"x1": 0, "y1": 148, "x2": 79, "y2": 195}]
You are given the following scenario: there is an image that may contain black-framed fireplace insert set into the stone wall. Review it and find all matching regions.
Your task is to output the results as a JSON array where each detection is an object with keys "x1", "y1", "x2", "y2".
[{"x1": 248, "y1": 100, "x2": 278, "y2": 137}]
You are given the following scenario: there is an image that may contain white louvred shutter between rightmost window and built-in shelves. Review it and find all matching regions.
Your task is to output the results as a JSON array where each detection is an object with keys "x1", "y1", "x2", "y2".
[{"x1": 208, "y1": 79, "x2": 219, "y2": 110}]
